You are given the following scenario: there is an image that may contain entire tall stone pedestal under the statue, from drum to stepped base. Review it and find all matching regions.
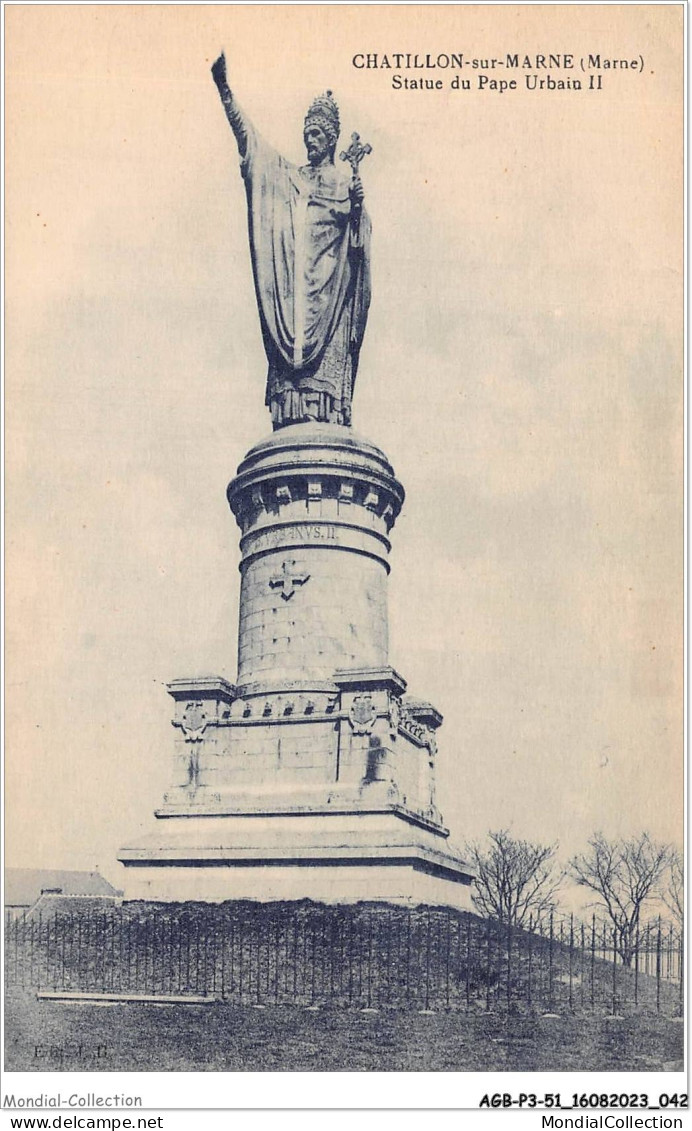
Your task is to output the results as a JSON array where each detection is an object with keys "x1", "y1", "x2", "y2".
[{"x1": 120, "y1": 424, "x2": 472, "y2": 907}]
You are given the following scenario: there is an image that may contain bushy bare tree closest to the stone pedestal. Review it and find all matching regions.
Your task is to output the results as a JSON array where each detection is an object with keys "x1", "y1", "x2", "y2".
[{"x1": 466, "y1": 829, "x2": 563, "y2": 927}]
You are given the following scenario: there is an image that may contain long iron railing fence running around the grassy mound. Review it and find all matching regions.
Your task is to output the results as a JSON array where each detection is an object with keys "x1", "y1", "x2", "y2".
[{"x1": 5, "y1": 904, "x2": 684, "y2": 1015}]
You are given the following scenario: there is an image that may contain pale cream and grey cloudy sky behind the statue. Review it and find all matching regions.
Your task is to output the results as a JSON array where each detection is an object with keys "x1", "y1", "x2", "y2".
[{"x1": 6, "y1": 5, "x2": 683, "y2": 900}]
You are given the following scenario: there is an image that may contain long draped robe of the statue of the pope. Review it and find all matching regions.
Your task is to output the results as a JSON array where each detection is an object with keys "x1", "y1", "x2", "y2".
[{"x1": 241, "y1": 116, "x2": 370, "y2": 428}]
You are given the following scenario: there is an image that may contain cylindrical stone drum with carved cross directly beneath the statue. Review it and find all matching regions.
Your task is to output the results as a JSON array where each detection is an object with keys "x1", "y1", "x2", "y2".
[{"x1": 228, "y1": 424, "x2": 404, "y2": 697}]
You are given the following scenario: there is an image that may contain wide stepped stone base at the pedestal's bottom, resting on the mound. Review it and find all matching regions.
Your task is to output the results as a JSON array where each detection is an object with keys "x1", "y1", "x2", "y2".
[{"x1": 120, "y1": 812, "x2": 472, "y2": 910}]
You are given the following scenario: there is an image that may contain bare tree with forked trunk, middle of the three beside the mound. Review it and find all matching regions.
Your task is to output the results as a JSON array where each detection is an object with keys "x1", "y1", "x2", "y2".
[{"x1": 570, "y1": 832, "x2": 671, "y2": 966}]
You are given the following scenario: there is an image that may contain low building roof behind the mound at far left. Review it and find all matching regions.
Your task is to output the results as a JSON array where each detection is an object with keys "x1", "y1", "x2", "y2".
[{"x1": 5, "y1": 867, "x2": 122, "y2": 920}]
